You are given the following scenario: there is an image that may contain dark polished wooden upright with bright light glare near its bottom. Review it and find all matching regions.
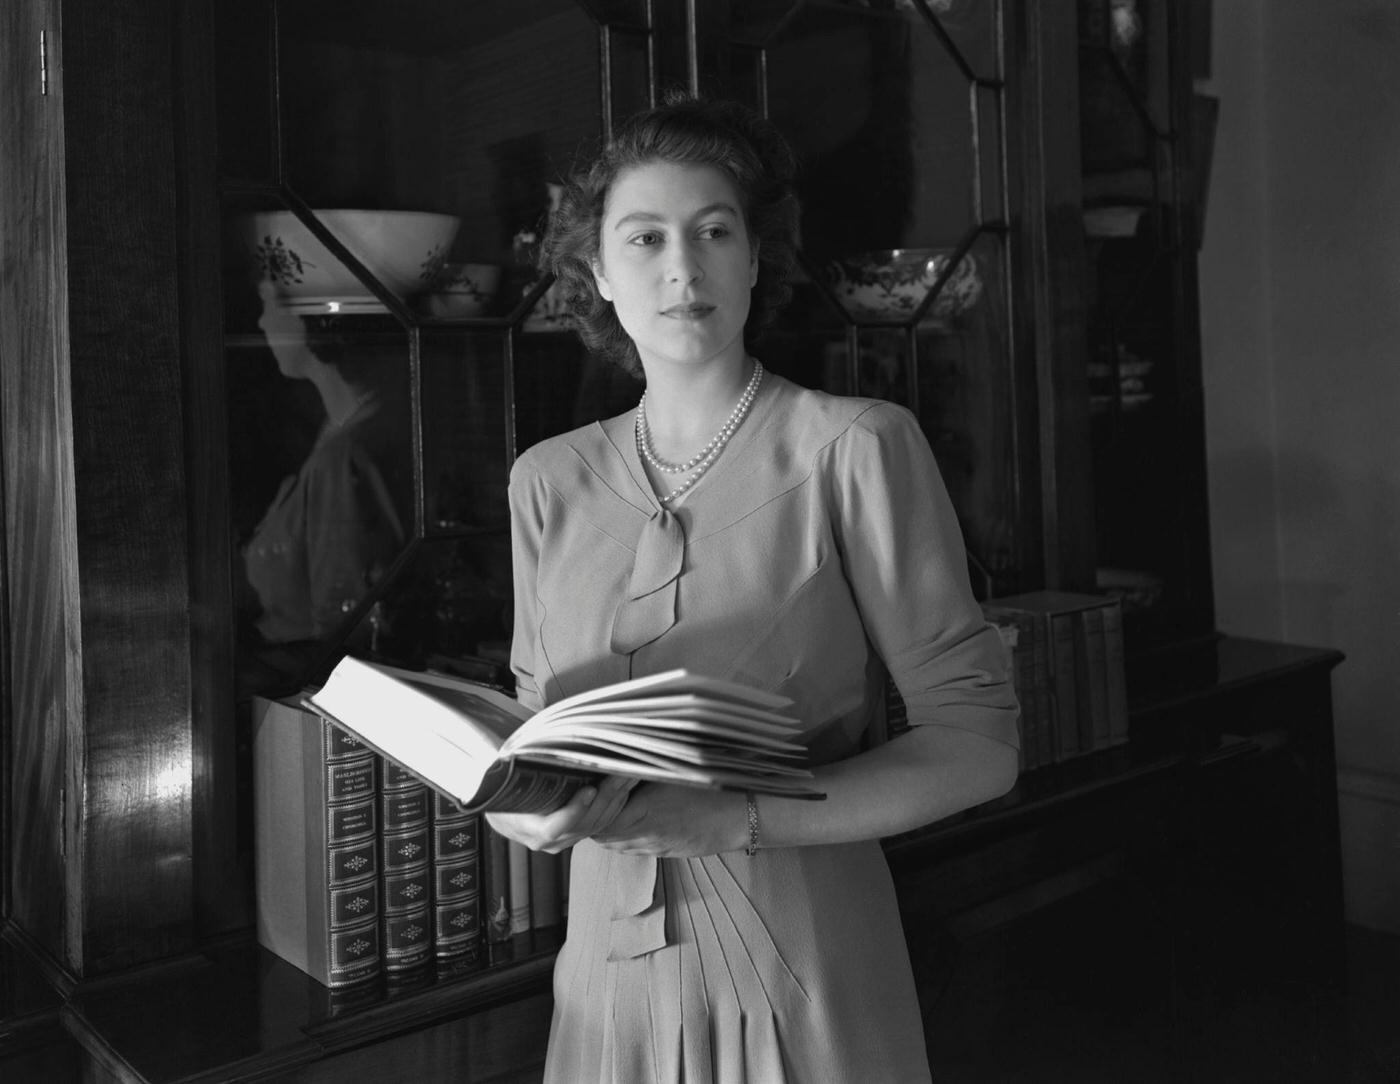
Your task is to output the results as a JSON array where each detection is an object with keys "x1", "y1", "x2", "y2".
[{"x1": 63, "y1": 0, "x2": 201, "y2": 973}]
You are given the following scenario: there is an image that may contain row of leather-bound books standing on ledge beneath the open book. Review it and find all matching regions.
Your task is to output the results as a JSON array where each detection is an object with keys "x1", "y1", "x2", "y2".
[{"x1": 253, "y1": 699, "x2": 568, "y2": 989}]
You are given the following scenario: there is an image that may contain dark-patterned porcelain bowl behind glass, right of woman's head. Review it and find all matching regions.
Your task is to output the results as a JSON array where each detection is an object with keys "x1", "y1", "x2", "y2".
[{"x1": 827, "y1": 248, "x2": 981, "y2": 321}]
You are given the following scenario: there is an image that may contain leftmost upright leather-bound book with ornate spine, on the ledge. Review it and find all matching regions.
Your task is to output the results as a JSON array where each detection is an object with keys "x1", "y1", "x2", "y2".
[{"x1": 253, "y1": 697, "x2": 382, "y2": 987}]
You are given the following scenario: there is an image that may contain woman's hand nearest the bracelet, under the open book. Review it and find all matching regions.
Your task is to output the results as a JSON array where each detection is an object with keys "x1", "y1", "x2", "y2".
[{"x1": 592, "y1": 783, "x2": 749, "y2": 859}]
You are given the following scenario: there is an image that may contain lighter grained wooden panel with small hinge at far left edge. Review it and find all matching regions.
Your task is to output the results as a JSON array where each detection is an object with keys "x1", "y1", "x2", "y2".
[{"x1": 0, "y1": 1, "x2": 78, "y2": 959}]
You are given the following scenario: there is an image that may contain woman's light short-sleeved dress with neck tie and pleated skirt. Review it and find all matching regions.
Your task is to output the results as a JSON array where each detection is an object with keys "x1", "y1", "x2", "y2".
[{"x1": 511, "y1": 374, "x2": 1016, "y2": 1084}]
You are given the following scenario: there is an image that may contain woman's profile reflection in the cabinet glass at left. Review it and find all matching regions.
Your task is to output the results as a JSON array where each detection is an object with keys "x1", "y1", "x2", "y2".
[{"x1": 235, "y1": 289, "x2": 413, "y2": 692}]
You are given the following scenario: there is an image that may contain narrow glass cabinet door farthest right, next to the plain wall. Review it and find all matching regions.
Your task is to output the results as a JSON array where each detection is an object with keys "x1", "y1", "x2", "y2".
[{"x1": 1078, "y1": 0, "x2": 1212, "y2": 646}]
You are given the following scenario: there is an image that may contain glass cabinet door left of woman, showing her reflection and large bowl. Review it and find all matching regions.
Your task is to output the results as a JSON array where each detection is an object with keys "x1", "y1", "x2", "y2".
[{"x1": 216, "y1": 0, "x2": 655, "y2": 696}]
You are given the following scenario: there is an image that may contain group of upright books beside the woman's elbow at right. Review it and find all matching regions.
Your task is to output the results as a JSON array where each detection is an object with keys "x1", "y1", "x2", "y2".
[{"x1": 983, "y1": 591, "x2": 1128, "y2": 770}]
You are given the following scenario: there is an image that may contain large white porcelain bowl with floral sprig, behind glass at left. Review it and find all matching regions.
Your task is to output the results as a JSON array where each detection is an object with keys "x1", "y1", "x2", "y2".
[{"x1": 239, "y1": 209, "x2": 462, "y2": 307}]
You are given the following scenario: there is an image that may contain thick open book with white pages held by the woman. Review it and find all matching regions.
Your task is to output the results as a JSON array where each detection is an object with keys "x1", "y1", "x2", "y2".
[{"x1": 305, "y1": 655, "x2": 825, "y2": 812}]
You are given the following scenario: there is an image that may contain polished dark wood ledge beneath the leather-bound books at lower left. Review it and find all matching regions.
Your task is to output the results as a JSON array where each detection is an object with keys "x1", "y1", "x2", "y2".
[{"x1": 57, "y1": 931, "x2": 559, "y2": 1084}]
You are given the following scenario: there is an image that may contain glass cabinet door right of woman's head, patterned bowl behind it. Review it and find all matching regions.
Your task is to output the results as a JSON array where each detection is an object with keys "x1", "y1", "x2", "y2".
[{"x1": 715, "y1": 0, "x2": 1039, "y2": 594}]
